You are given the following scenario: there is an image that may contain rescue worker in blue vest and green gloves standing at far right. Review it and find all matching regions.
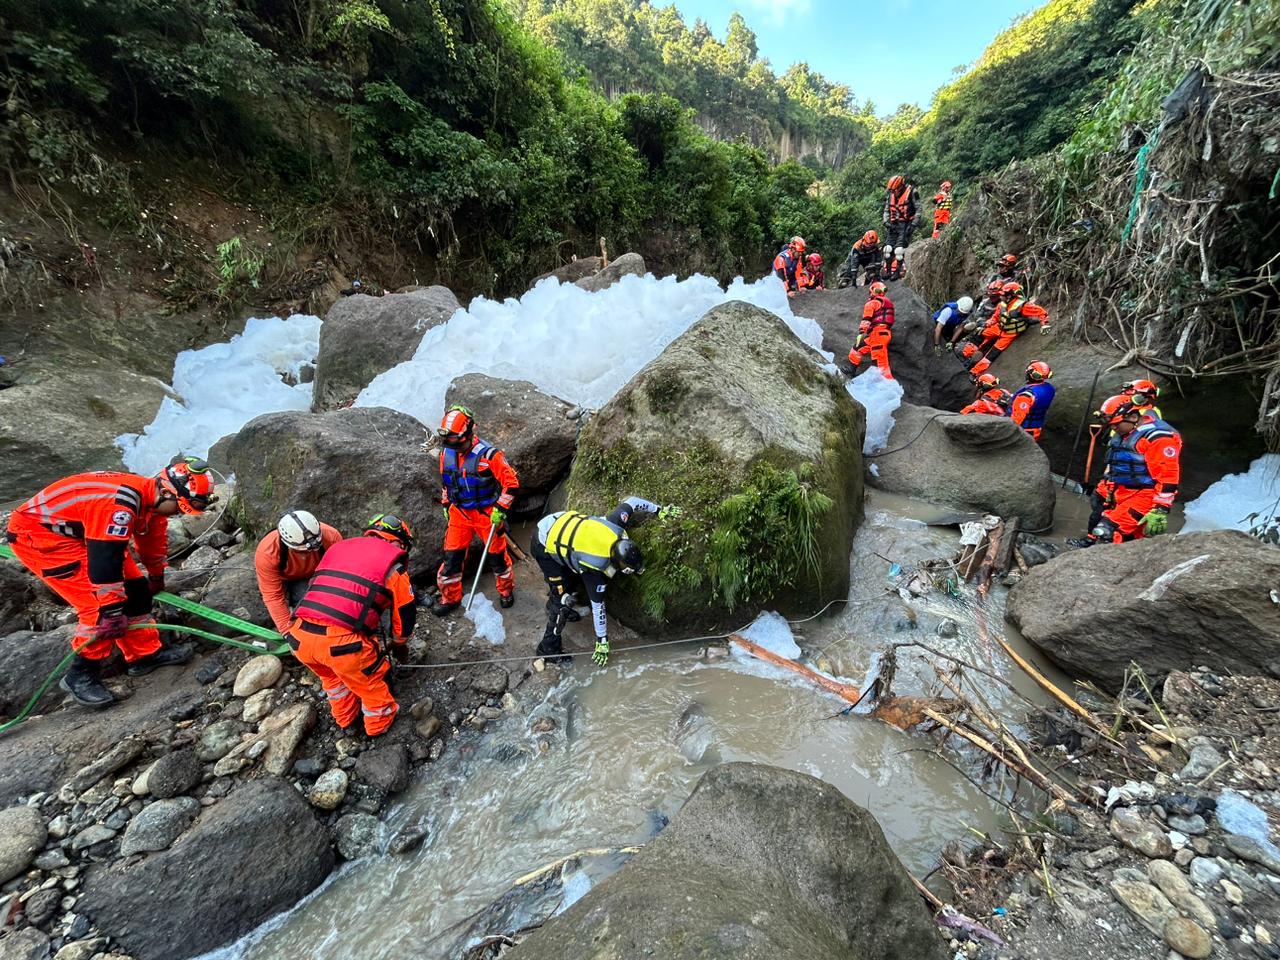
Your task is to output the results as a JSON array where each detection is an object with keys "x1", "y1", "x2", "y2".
[{"x1": 1070, "y1": 394, "x2": 1183, "y2": 547}]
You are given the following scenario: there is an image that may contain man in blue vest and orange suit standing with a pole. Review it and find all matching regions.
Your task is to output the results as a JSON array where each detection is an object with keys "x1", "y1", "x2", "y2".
[{"x1": 431, "y1": 404, "x2": 520, "y2": 617}]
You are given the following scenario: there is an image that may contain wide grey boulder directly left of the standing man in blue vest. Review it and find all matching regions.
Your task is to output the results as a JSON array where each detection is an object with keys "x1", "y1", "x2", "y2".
[{"x1": 227, "y1": 407, "x2": 444, "y2": 576}]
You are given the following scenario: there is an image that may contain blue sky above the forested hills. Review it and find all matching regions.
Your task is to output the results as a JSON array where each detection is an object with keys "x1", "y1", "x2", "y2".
[{"x1": 657, "y1": 0, "x2": 1044, "y2": 115}]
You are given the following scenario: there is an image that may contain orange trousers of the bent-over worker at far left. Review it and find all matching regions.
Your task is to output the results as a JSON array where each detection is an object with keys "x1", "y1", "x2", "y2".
[{"x1": 10, "y1": 530, "x2": 160, "y2": 663}]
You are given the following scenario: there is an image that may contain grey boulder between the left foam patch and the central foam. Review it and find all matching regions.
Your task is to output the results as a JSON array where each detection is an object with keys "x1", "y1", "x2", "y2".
[{"x1": 311, "y1": 287, "x2": 461, "y2": 410}]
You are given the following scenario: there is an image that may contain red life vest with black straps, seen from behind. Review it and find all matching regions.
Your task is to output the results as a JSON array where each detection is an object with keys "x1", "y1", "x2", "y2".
[{"x1": 296, "y1": 536, "x2": 407, "y2": 634}]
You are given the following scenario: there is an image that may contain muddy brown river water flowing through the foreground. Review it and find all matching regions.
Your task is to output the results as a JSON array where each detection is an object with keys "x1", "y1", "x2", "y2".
[{"x1": 207, "y1": 493, "x2": 1080, "y2": 960}]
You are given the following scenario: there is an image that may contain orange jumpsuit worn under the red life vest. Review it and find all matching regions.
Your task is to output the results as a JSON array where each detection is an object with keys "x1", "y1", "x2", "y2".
[{"x1": 285, "y1": 536, "x2": 417, "y2": 736}]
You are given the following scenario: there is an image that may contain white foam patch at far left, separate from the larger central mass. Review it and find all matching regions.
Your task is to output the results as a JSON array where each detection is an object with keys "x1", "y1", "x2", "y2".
[{"x1": 115, "y1": 314, "x2": 320, "y2": 474}]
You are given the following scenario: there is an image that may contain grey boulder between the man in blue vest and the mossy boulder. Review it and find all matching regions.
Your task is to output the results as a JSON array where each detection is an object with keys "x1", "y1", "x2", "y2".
[{"x1": 444, "y1": 374, "x2": 579, "y2": 516}]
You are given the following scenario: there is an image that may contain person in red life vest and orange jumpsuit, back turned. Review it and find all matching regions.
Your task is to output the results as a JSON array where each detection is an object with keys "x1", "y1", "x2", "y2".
[{"x1": 284, "y1": 513, "x2": 417, "y2": 737}]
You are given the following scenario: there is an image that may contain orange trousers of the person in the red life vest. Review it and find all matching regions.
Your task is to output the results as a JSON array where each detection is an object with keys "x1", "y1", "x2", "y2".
[{"x1": 285, "y1": 618, "x2": 399, "y2": 737}]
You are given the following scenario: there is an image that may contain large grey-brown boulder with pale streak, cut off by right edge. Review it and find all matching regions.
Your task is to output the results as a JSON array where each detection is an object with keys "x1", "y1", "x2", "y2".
[{"x1": 1005, "y1": 530, "x2": 1280, "y2": 690}]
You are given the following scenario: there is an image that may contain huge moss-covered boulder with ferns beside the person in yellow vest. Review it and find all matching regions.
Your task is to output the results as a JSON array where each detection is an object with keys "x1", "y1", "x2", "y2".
[{"x1": 568, "y1": 301, "x2": 865, "y2": 628}]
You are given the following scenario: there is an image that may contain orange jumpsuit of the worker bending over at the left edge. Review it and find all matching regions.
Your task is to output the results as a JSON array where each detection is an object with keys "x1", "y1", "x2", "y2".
[{"x1": 8, "y1": 471, "x2": 169, "y2": 663}]
